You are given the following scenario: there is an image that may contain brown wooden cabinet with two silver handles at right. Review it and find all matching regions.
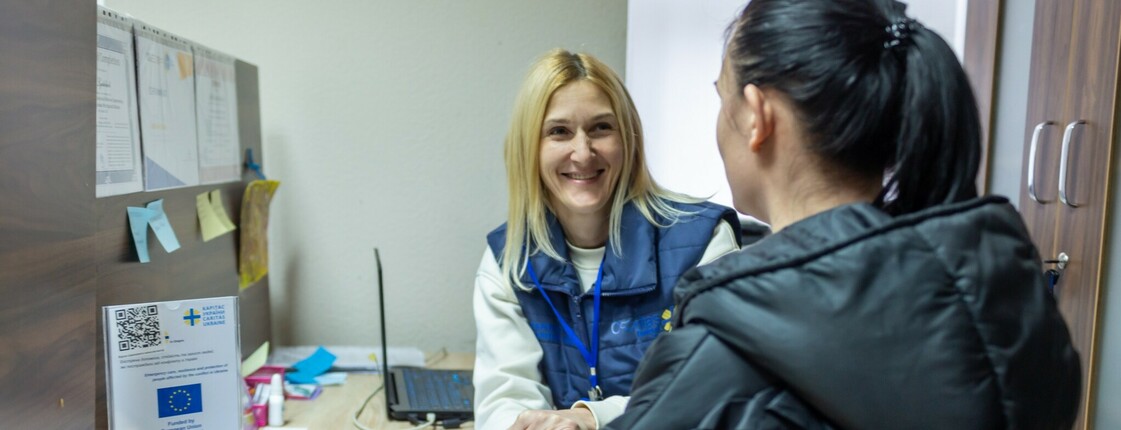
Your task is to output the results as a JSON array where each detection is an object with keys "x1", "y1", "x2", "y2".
[{"x1": 1020, "y1": 0, "x2": 1121, "y2": 428}]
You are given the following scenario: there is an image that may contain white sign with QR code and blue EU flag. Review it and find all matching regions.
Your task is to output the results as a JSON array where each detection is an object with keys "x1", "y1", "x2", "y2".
[{"x1": 102, "y1": 297, "x2": 242, "y2": 430}]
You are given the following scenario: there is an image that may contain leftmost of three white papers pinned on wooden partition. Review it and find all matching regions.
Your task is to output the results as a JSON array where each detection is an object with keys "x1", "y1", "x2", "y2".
[{"x1": 94, "y1": 8, "x2": 143, "y2": 197}]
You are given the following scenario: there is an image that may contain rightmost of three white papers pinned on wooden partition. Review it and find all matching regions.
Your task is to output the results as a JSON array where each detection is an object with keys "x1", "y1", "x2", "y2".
[{"x1": 194, "y1": 45, "x2": 241, "y2": 184}]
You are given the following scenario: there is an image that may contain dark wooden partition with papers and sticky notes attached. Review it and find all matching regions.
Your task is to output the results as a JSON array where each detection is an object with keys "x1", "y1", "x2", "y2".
[{"x1": 0, "y1": 0, "x2": 270, "y2": 429}]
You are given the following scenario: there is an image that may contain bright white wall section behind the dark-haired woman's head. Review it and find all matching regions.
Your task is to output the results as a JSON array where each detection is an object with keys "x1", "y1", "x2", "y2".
[{"x1": 627, "y1": 0, "x2": 966, "y2": 215}]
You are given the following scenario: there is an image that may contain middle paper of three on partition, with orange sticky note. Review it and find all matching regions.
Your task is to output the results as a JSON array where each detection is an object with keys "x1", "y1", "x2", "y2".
[{"x1": 133, "y1": 22, "x2": 198, "y2": 191}]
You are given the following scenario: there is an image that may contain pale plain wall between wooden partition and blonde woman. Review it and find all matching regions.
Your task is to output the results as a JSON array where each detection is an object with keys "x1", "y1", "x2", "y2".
[{"x1": 105, "y1": 0, "x2": 627, "y2": 350}]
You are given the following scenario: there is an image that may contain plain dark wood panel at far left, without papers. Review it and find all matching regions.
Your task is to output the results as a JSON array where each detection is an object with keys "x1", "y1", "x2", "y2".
[{"x1": 0, "y1": 0, "x2": 96, "y2": 429}]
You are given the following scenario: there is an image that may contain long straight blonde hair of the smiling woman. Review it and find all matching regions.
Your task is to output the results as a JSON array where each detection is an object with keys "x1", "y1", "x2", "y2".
[{"x1": 500, "y1": 49, "x2": 700, "y2": 288}]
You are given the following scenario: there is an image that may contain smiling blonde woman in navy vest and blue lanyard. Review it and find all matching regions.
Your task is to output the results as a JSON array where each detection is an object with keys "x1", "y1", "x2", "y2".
[{"x1": 474, "y1": 50, "x2": 739, "y2": 429}]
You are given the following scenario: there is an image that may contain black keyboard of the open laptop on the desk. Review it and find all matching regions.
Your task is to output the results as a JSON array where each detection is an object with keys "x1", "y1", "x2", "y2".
[{"x1": 401, "y1": 368, "x2": 474, "y2": 412}]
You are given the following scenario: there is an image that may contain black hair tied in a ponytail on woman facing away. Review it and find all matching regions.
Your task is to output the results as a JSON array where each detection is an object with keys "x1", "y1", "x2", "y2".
[{"x1": 728, "y1": 0, "x2": 981, "y2": 214}]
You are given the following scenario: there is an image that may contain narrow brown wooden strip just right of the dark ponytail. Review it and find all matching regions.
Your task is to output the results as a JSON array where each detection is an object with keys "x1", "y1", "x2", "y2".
[{"x1": 962, "y1": 0, "x2": 1001, "y2": 194}]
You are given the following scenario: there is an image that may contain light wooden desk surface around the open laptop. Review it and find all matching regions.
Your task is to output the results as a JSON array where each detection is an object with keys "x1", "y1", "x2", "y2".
[{"x1": 284, "y1": 353, "x2": 475, "y2": 430}]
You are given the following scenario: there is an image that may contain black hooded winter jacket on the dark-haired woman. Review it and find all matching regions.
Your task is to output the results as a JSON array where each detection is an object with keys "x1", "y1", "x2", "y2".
[{"x1": 608, "y1": 197, "x2": 1081, "y2": 429}]
